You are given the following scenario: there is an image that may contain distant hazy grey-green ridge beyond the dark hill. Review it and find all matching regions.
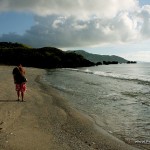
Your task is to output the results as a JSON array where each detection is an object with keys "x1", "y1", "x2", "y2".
[{"x1": 73, "y1": 50, "x2": 128, "y2": 63}]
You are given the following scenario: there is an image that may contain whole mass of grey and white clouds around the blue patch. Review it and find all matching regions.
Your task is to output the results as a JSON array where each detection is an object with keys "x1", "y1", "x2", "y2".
[{"x1": 0, "y1": 0, "x2": 150, "y2": 48}]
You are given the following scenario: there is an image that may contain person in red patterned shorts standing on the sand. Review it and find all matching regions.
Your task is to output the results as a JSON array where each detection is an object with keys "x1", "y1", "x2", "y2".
[{"x1": 12, "y1": 64, "x2": 27, "y2": 102}]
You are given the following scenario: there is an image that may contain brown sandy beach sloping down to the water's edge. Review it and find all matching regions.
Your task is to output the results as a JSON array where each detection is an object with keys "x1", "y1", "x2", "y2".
[{"x1": 0, "y1": 66, "x2": 140, "y2": 150}]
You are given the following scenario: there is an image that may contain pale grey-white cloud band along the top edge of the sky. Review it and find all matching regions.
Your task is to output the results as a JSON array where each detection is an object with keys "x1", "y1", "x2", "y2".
[{"x1": 0, "y1": 0, "x2": 138, "y2": 17}]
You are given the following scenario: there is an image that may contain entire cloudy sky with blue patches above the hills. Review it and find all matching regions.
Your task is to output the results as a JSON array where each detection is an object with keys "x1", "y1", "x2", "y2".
[{"x1": 0, "y1": 0, "x2": 150, "y2": 62}]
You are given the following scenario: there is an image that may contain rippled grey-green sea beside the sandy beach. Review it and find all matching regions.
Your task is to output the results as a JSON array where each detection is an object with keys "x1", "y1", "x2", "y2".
[{"x1": 43, "y1": 63, "x2": 150, "y2": 149}]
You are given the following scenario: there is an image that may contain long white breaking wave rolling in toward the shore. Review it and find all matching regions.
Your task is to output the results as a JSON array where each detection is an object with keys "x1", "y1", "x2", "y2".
[{"x1": 63, "y1": 68, "x2": 150, "y2": 84}]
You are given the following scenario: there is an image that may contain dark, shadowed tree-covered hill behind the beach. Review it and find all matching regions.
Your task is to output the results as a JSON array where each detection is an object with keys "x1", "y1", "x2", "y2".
[{"x1": 0, "y1": 42, "x2": 95, "y2": 68}]
